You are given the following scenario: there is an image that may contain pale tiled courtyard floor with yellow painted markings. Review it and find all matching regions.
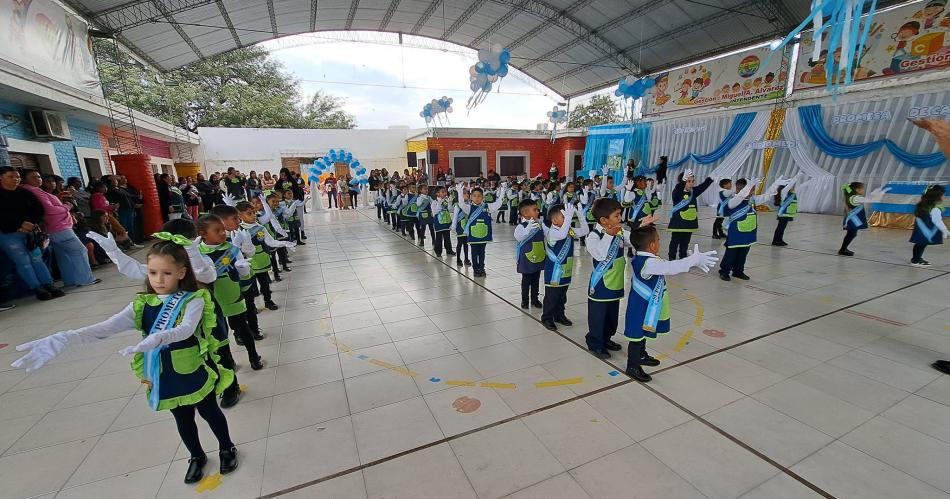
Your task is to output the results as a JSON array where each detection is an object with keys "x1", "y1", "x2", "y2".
[{"x1": 0, "y1": 205, "x2": 950, "y2": 499}]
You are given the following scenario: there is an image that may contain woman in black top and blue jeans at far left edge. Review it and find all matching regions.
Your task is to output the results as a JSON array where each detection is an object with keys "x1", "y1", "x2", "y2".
[{"x1": 0, "y1": 166, "x2": 63, "y2": 301}]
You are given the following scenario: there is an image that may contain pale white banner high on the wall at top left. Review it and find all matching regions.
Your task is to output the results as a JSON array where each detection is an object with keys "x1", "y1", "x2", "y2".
[{"x1": 0, "y1": 0, "x2": 102, "y2": 96}]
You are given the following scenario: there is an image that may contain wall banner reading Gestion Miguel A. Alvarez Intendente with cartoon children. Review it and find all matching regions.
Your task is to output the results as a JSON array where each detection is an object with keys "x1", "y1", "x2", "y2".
[{"x1": 643, "y1": 46, "x2": 788, "y2": 114}]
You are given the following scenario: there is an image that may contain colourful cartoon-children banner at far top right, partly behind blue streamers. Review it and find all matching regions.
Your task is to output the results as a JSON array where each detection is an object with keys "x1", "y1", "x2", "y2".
[{"x1": 795, "y1": 0, "x2": 950, "y2": 90}]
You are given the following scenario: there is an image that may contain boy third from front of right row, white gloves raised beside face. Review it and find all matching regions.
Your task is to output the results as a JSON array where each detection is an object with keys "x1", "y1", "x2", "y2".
[{"x1": 541, "y1": 203, "x2": 587, "y2": 331}]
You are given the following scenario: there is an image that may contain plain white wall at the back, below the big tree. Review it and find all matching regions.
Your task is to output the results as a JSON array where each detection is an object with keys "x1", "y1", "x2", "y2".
[{"x1": 195, "y1": 128, "x2": 411, "y2": 173}]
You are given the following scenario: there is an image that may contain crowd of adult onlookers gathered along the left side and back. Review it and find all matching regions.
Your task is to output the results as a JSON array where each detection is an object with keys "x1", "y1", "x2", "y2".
[{"x1": 0, "y1": 166, "x2": 305, "y2": 311}]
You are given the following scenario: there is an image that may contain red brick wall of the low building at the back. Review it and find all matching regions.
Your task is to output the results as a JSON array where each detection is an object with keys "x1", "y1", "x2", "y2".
[{"x1": 428, "y1": 137, "x2": 585, "y2": 177}]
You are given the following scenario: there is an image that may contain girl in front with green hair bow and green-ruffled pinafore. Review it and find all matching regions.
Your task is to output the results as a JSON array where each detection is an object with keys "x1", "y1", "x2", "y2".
[{"x1": 12, "y1": 240, "x2": 238, "y2": 483}]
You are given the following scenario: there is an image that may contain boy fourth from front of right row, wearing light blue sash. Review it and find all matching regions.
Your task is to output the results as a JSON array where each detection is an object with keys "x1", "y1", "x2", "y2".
[{"x1": 515, "y1": 199, "x2": 546, "y2": 309}]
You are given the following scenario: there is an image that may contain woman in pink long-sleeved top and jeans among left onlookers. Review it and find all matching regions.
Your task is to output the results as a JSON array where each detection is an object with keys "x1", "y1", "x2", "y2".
[{"x1": 21, "y1": 170, "x2": 101, "y2": 286}]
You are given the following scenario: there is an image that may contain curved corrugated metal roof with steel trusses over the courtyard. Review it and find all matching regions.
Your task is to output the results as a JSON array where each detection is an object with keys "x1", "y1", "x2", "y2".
[{"x1": 64, "y1": 0, "x2": 899, "y2": 97}]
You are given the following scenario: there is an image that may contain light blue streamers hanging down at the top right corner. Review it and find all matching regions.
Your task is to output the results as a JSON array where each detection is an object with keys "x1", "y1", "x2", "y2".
[{"x1": 765, "y1": 0, "x2": 877, "y2": 94}]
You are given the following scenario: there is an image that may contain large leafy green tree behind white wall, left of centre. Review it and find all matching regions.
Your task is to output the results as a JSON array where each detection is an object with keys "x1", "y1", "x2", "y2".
[{"x1": 96, "y1": 39, "x2": 356, "y2": 132}]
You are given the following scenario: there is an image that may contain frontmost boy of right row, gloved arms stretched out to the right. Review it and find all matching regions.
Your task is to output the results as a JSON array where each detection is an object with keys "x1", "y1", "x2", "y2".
[{"x1": 623, "y1": 225, "x2": 718, "y2": 383}]
